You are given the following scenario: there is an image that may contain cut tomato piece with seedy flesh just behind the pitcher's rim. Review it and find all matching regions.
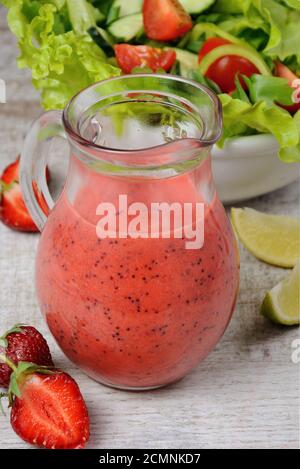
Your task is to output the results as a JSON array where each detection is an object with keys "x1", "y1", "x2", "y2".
[{"x1": 114, "y1": 44, "x2": 176, "y2": 73}]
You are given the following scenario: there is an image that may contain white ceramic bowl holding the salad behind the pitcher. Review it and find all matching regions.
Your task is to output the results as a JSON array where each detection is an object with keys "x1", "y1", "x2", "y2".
[{"x1": 212, "y1": 135, "x2": 300, "y2": 203}]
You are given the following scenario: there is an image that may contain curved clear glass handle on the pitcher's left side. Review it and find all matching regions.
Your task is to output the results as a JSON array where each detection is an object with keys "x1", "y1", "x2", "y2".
[{"x1": 20, "y1": 111, "x2": 66, "y2": 231}]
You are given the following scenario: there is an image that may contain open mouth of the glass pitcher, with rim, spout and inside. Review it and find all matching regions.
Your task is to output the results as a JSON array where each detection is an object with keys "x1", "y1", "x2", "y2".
[{"x1": 63, "y1": 74, "x2": 222, "y2": 166}]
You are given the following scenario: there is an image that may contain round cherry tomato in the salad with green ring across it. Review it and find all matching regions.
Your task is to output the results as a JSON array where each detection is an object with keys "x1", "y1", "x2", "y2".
[{"x1": 199, "y1": 37, "x2": 259, "y2": 93}]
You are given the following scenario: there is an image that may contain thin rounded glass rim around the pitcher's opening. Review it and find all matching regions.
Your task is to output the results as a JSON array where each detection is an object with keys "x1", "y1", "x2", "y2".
[{"x1": 62, "y1": 73, "x2": 222, "y2": 158}]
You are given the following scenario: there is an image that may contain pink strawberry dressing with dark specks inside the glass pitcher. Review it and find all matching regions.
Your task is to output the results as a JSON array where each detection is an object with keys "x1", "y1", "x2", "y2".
[{"x1": 36, "y1": 159, "x2": 239, "y2": 389}]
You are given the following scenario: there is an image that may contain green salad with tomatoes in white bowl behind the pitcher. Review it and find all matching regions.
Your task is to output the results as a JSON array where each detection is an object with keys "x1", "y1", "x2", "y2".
[{"x1": 0, "y1": 0, "x2": 300, "y2": 197}]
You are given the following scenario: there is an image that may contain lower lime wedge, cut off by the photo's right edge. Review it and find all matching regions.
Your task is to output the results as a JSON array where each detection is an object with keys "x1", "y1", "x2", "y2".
[{"x1": 260, "y1": 262, "x2": 300, "y2": 326}]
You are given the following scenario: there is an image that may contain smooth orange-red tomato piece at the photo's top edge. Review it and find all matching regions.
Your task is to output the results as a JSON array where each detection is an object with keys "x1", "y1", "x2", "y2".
[{"x1": 143, "y1": 0, "x2": 193, "y2": 41}]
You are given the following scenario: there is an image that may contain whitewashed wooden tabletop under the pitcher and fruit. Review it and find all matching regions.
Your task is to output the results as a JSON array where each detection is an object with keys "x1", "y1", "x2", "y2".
[{"x1": 0, "y1": 10, "x2": 300, "y2": 448}]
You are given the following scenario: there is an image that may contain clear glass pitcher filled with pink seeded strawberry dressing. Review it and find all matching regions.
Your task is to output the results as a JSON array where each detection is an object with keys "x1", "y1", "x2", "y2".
[{"x1": 21, "y1": 74, "x2": 239, "y2": 390}]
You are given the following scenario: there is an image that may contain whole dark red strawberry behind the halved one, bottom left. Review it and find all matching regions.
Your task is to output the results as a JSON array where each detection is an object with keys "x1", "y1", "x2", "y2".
[{"x1": 0, "y1": 324, "x2": 53, "y2": 387}]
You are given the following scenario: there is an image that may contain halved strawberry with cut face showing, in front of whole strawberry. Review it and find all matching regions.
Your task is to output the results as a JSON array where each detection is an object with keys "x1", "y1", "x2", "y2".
[{"x1": 10, "y1": 363, "x2": 90, "y2": 449}]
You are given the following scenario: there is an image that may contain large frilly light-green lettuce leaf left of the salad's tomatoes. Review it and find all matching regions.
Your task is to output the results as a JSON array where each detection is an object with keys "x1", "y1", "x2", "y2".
[{"x1": 4, "y1": 0, "x2": 120, "y2": 109}]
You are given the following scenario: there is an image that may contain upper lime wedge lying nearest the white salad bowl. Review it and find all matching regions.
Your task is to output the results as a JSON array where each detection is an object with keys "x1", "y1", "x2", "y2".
[{"x1": 231, "y1": 208, "x2": 300, "y2": 267}]
